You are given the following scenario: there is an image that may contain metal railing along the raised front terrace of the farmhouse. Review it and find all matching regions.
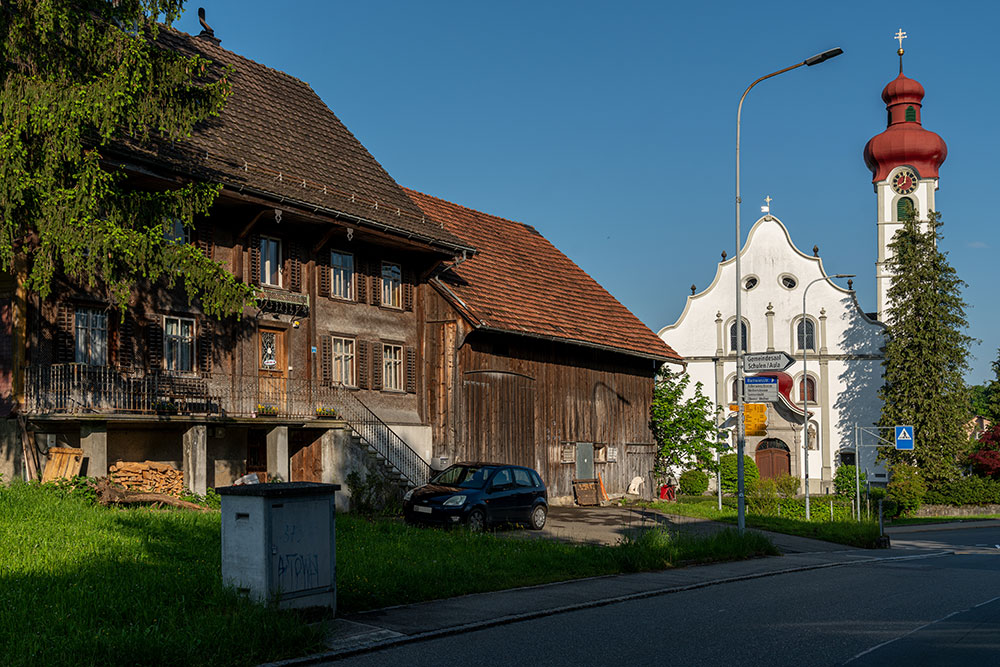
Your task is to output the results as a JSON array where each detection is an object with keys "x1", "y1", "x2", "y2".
[{"x1": 24, "y1": 364, "x2": 346, "y2": 420}]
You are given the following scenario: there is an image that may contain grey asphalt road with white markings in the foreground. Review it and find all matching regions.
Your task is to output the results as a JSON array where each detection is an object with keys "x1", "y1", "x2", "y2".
[{"x1": 328, "y1": 527, "x2": 1000, "y2": 667}]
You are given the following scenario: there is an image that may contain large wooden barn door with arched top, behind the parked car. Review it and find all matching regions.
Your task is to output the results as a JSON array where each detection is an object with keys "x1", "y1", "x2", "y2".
[{"x1": 458, "y1": 371, "x2": 536, "y2": 467}]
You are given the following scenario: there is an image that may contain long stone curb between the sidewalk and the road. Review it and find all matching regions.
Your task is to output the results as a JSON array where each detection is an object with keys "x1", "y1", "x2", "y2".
[{"x1": 259, "y1": 551, "x2": 955, "y2": 667}]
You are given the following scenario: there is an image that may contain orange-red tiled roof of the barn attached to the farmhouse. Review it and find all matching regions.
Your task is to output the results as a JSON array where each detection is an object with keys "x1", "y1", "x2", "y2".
[{"x1": 406, "y1": 189, "x2": 682, "y2": 361}]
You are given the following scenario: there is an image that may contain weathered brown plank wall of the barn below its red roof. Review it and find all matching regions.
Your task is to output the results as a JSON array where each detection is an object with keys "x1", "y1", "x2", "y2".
[{"x1": 423, "y1": 288, "x2": 656, "y2": 498}]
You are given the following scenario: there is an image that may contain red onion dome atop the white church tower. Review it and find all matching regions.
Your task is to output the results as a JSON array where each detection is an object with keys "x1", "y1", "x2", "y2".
[{"x1": 865, "y1": 72, "x2": 948, "y2": 183}]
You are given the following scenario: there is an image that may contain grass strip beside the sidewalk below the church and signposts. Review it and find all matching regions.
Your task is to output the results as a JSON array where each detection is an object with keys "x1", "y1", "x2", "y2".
[{"x1": 650, "y1": 496, "x2": 878, "y2": 549}]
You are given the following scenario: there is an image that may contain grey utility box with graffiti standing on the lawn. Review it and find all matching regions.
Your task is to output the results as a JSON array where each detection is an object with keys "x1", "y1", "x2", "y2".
[{"x1": 216, "y1": 482, "x2": 340, "y2": 610}]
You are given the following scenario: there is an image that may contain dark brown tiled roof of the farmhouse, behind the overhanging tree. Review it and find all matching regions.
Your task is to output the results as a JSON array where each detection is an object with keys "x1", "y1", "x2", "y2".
[{"x1": 119, "y1": 28, "x2": 467, "y2": 250}]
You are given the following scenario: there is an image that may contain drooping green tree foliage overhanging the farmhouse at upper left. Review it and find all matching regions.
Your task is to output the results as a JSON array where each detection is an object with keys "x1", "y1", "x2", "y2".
[{"x1": 0, "y1": 0, "x2": 252, "y2": 315}]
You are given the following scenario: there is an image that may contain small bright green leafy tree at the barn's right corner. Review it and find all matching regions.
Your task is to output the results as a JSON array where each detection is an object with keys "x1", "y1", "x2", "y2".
[{"x1": 649, "y1": 366, "x2": 719, "y2": 479}]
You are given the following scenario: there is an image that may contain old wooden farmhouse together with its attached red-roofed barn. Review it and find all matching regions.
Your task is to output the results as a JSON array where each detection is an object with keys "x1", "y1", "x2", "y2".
[{"x1": 0, "y1": 30, "x2": 680, "y2": 506}]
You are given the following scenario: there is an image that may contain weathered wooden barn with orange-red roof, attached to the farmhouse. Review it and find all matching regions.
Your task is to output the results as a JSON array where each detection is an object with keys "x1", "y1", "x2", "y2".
[{"x1": 408, "y1": 191, "x2": 682, "y2": 502}]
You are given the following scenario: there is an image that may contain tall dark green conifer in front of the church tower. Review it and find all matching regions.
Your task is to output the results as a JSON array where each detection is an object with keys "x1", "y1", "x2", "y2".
[{"x1": 879, "y1": 212, "x2": 972, "y2": 485}]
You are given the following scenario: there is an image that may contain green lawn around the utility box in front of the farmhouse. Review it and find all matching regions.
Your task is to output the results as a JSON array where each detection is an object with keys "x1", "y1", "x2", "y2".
[{"x1": 0, "y1": 483, "x2": 777, "y2": 667}]
